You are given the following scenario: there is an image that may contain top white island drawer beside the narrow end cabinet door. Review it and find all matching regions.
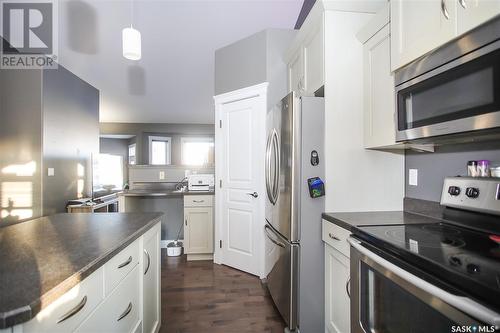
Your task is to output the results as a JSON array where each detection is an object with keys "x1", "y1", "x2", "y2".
[{"x1": 104, "y1": 240, "x2": 140, "y2": 296}]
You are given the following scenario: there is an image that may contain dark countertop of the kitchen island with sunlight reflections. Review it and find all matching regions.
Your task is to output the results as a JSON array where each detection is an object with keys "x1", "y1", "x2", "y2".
[{"x1": 0, "y1": 213, "x2": 162, "y2": 329}]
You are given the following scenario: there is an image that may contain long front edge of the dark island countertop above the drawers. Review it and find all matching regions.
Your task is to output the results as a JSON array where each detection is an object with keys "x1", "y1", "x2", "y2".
[{"x1": 0, "y1": 213, "x2": 164, "y2": 329}]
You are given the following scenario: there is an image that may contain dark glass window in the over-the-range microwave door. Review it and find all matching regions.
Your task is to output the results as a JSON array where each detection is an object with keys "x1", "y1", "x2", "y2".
[{"x1": 397, "y1": 51, "x2": 500, "y2": 131}]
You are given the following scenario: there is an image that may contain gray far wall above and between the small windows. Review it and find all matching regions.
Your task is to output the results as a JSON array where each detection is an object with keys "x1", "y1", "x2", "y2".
[{"x1": 100, "y1": 123, "x2": 215, "y2": 165}]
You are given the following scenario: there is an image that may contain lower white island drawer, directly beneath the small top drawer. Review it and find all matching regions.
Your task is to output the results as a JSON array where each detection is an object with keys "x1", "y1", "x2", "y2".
[{"x1": 75, "y1": 265, "x2": 140, "y2": 333}]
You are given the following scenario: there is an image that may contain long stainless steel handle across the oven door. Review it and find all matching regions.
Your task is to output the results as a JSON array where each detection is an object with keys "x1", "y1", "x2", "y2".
[{"x1": 348, "y1": 237, "x2": 500, "y2": 328}]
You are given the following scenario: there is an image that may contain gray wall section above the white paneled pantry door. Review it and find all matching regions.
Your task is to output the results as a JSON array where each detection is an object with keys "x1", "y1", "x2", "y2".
[{"x1": 215, "y1": 29, "x2": 297, "y2": 107}]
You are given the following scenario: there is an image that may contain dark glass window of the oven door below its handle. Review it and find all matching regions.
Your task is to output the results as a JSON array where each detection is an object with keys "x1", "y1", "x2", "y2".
[{"x1": 359, "y1": 261, "x2": 467, "y2": 333}]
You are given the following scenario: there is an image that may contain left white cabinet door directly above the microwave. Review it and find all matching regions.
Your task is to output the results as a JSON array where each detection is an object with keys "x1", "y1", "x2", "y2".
[{"x1": 390, "y1": 0, "x2": 457, "y2": 70}]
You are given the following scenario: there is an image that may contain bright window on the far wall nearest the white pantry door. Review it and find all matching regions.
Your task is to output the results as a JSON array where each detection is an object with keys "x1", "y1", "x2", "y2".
[{"x1": 181, "y1": 137, "x2": 214, "y2": 166}]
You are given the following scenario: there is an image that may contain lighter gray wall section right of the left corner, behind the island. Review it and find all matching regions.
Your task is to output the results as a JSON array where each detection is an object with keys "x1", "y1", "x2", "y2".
[{"x1": 43, "y1": 66, "x2": 99, "y2": 215}]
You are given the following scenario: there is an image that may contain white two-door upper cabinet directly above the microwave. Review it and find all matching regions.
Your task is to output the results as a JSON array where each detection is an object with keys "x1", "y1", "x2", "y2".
[{"x1": 390, "y1": 0, "x2": 500, "y2": 70}]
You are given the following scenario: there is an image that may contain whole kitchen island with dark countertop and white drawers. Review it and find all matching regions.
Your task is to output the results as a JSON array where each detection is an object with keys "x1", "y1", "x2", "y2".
[{"x1": 0, "y1": 213, "x2": 162, "y2": 333}]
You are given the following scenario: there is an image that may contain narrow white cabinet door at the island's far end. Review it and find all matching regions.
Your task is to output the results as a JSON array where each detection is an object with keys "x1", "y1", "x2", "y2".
[{"x1": 142, "y1": 224, "x2": 161, "y2": 333}]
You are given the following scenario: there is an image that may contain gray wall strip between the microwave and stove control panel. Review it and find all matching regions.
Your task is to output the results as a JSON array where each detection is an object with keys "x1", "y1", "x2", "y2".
[{"x1": 405, "y1": 141, "x2": 500, "y2": 201}]
